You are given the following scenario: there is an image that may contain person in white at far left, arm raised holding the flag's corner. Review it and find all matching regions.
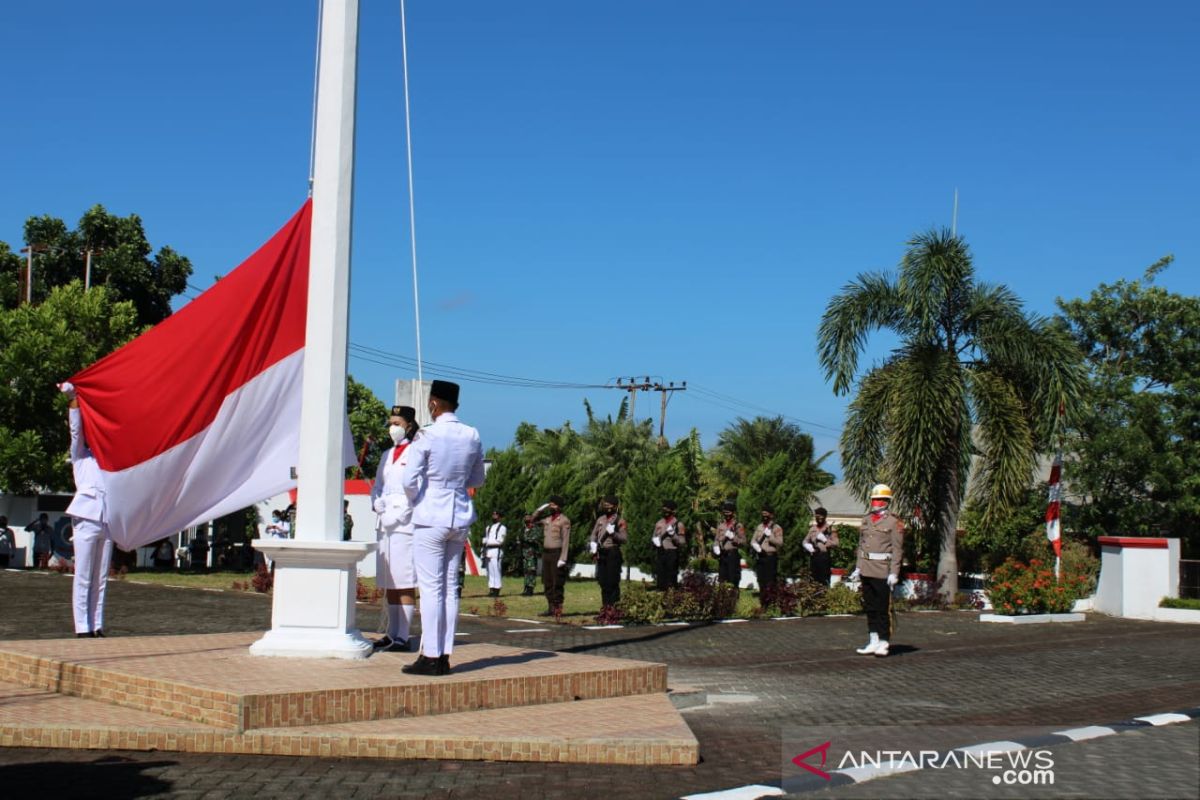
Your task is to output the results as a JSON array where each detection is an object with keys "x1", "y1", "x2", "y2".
[{"x1": 59, "y1": 383, "x2": 113, "y2": 639}]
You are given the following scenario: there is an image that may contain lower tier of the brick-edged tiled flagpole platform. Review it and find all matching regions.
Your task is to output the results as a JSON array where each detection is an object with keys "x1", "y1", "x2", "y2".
[{"x1": 0, "y1": 682, "x2": 700, "y2": 765}]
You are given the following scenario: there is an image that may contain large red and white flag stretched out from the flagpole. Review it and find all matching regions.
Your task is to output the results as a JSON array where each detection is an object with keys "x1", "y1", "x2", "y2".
[{"x1": 71, "y1": 200, "x2": 324, "y2": 549}]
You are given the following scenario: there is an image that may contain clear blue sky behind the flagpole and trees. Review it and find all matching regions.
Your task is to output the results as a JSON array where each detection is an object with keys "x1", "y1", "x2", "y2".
[{"x1": 0, "y1": 0, "x2": 1200, "y2": 472}]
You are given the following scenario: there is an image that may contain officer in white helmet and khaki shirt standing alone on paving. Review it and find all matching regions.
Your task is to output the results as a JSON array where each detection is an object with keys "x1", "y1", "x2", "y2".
[{"x1": 850, "y1": 483, "x2": 904, "y2": 657}]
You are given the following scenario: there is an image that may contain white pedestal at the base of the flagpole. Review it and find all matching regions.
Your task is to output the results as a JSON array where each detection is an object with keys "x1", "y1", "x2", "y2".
[{"x1": 250, "y1": 539, "x2": 376, "y2": 658}]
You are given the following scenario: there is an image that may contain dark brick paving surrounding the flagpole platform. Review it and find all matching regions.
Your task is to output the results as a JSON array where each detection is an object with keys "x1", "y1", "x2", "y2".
[{"x1": 0, "y1": 572, "x2": 1200, "y2": 800}]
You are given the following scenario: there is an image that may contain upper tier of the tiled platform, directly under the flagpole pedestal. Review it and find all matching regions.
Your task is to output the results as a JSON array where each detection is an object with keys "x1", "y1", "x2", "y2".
[{"x1": 0, "y1": 632, "x2": 667, "y2": 733}]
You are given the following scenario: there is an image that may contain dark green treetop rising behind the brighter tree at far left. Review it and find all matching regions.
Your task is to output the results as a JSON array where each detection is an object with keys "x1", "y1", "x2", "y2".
[{"x1": 0, "y1": 205, "x2": 192, "y2": 325}]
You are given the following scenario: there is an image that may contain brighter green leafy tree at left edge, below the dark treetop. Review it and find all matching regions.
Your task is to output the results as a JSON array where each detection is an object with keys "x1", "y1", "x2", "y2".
[{"x1": 0, "y1": 282, "x2": 140, "y2": 494}]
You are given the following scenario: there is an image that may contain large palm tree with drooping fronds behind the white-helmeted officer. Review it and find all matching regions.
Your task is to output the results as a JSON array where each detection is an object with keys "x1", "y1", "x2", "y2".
[{"x1": 817, "y1": 230, "x2": 1085, "y2": 599}]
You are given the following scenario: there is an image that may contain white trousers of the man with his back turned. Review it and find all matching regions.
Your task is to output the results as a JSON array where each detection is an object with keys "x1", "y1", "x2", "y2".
[{"x1": 413, "y1": 525, "x2": 467, "y2": 658}]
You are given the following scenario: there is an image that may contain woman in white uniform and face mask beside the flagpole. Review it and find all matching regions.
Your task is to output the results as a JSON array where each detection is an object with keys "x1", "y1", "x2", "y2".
[{"x1": 371, "y1": 405, "x2": 419, "y2": 652}]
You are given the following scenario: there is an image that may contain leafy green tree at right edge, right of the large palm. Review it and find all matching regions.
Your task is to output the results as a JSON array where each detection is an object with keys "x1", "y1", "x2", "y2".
[{"x1": 1058, "y1": 255, "x2": 1200, "y2": 548}]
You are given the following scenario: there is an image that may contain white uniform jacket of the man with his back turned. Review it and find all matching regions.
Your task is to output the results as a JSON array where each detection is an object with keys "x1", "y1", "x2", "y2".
[{"x1": 401, "y1": 411, "x2": 484, "y2": 528}]
